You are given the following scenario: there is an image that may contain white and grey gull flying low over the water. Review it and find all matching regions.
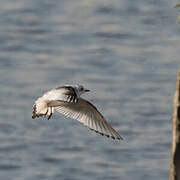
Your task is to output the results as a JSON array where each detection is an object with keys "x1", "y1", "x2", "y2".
[{"x1": 32, "y1": 84, "x2": 123, "y2": 140}]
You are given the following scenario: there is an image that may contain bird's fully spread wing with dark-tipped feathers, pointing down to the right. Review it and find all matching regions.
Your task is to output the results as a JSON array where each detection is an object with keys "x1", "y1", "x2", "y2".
[{"x1": 54, "y1": 98, "x2": 123, "y2": 140}]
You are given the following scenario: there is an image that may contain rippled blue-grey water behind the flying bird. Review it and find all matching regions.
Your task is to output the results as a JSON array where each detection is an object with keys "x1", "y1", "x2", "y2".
[{"x1": 0, "y1": 0, "x2": 180, "y2": 180}]
